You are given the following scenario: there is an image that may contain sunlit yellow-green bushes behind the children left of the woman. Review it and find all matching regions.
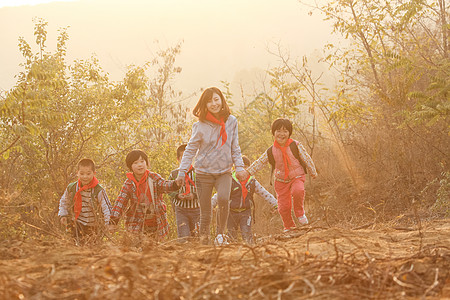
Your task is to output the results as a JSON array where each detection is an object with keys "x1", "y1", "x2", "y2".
[{"x1": 0, "y1": 19, "x2": 187, "y2": 239}]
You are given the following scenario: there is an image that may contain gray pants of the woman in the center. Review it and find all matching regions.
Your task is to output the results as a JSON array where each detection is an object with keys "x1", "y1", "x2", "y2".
[{"x1": 195, "y1": 173, "x2": 232, "y2": 236}]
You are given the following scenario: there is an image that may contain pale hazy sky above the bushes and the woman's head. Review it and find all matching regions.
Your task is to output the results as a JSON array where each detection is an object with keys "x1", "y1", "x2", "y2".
[{"x1": 0, "y1": 0, "x2": 338, "y2": 102}]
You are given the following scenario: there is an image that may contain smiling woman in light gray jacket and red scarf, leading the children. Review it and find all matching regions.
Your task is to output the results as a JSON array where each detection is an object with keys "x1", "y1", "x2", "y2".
[{"x1": 177, "y1": 87, "x2": 246, "y2": 245}]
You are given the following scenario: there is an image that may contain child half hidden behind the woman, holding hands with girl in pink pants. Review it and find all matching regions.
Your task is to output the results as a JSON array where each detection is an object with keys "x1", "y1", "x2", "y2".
[{"x1": 212, "y1": 155, "x2": 277, "y2": 244}]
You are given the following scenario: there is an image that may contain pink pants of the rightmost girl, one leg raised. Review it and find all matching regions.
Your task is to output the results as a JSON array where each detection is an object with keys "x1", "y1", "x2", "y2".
[{"x1": 275, "y1": 175, "x2": 305, "y2": 229}]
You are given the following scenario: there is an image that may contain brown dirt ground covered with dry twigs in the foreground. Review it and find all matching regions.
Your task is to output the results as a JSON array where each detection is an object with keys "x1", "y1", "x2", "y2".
[{"x1": 0, "y1": 219, "x2": 450, "y2": 299}]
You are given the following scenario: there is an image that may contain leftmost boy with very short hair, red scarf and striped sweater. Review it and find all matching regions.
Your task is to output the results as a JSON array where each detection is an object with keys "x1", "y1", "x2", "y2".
[{"x1": 58, "y1": 158, "x2": 111, "y2": 237}]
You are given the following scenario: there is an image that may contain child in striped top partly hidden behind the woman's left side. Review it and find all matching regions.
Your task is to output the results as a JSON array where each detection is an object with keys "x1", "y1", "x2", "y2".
[{"x1": 169, "y1": 144, "x2": 200, "y2": 242}]
